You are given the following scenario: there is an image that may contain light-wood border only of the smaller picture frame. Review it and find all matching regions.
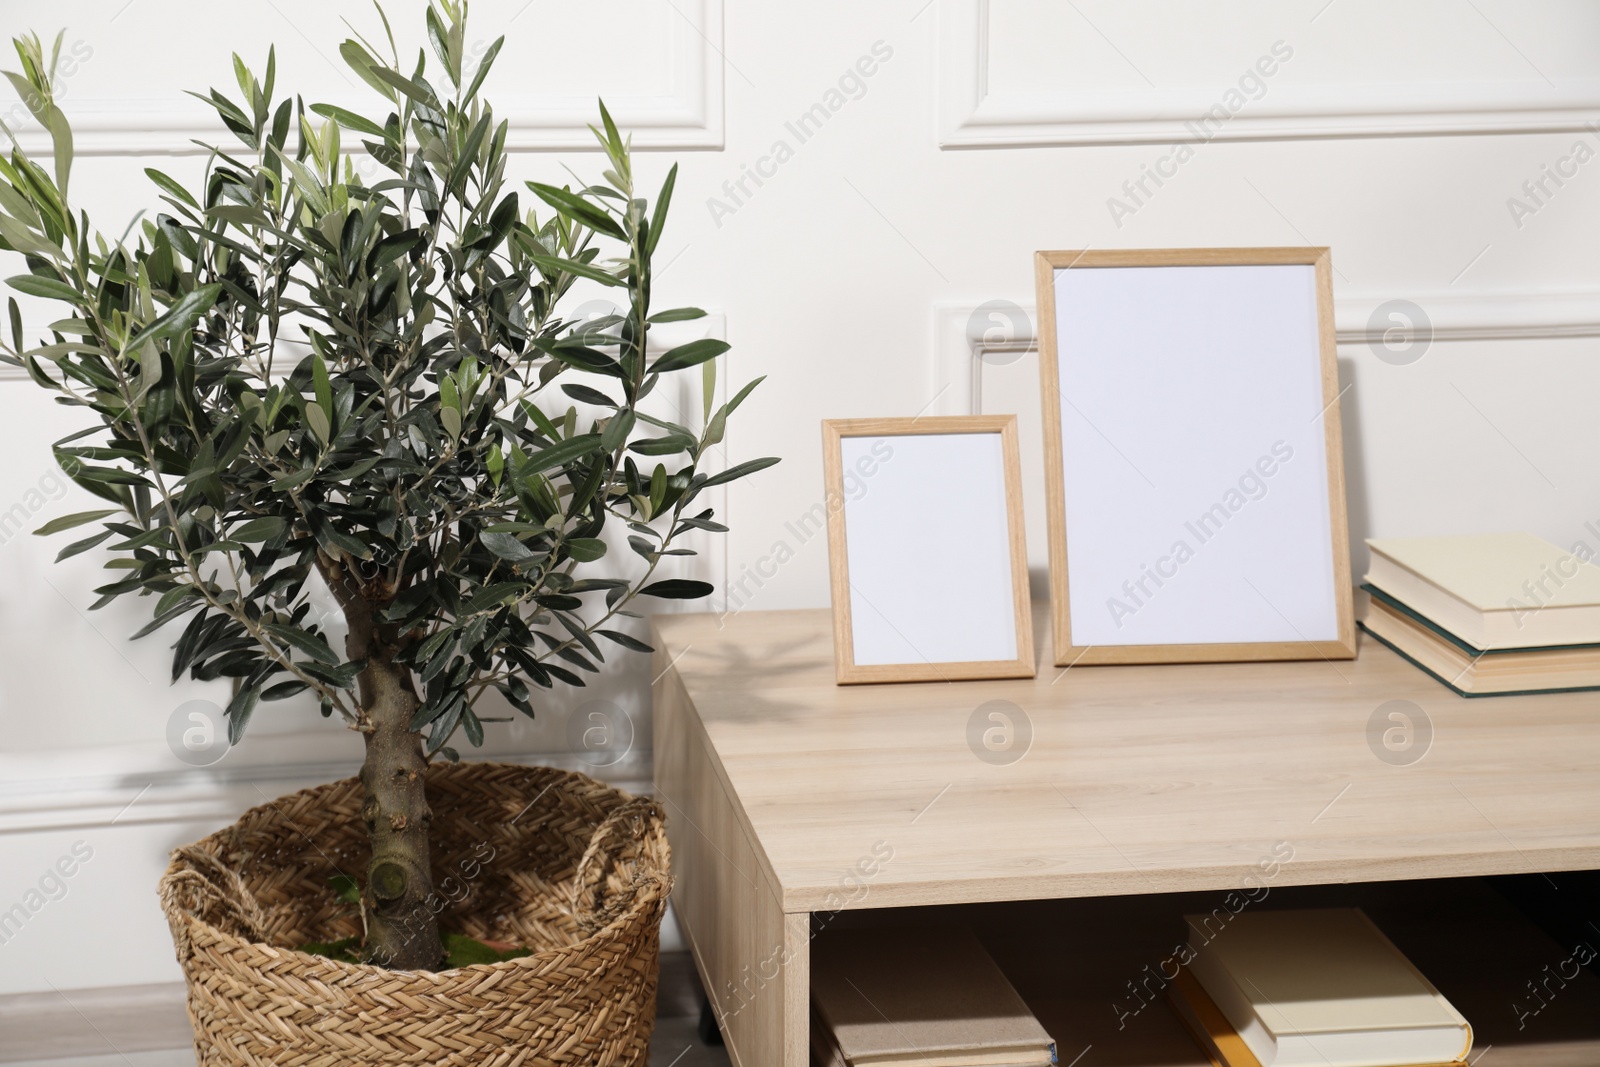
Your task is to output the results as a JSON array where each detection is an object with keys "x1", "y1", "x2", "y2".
[{"x1": 822, "y1": 414, "x2": 1035, "y2": 685}]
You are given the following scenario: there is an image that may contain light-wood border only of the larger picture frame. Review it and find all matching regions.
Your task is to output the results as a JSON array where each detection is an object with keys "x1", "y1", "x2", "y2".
[{"x1": 1034, "y1": 248, "x2": 1355, "y2": 667}]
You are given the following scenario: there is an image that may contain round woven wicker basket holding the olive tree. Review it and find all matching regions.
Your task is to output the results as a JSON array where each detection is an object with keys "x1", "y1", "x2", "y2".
[{"x1": 160, "y1": 763, "x2": 672, "y2": 1067}]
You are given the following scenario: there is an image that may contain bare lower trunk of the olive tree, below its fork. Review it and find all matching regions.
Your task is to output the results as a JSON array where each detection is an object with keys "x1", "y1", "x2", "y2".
[{"x1": 362, "y1": 661, "x2": 445, "y2": 971}]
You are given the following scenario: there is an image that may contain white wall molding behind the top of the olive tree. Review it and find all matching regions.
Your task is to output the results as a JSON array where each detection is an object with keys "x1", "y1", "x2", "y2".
[{"x1": 6, "y1": 0, "x2": 725, "y2": 157}]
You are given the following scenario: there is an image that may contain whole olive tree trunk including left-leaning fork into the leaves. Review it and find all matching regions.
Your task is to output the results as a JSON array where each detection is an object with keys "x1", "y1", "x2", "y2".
[{"x1": 317, "y1": 555, "x2": 445, "y2": 971}]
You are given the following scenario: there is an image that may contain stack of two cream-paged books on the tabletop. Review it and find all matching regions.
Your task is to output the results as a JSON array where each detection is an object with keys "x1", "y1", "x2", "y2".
[{"x1": 1362, "y1": 533, "x2": 1600, "y2": 696}]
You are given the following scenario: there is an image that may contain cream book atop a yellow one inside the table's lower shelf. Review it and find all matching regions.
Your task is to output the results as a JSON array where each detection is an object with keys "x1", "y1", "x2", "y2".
[{"x1": 1170, "y1": 909, "x2": 1472, "y2": 1067}]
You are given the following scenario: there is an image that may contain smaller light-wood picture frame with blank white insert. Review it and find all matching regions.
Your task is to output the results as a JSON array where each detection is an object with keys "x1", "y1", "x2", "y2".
[{"x1": 822, "y1": 414, "x2": 1034, "y2": 685}]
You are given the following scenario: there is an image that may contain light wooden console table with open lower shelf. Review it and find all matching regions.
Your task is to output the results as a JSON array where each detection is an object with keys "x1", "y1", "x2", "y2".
[{"x1": 654, "y1": 611, "x2": 1600, "y2": 1067}]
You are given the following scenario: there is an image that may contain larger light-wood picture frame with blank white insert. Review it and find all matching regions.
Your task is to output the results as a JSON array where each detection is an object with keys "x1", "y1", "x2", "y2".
[{"x1": 1035, "y1": 248, "x2": 1355, "y2": 665}]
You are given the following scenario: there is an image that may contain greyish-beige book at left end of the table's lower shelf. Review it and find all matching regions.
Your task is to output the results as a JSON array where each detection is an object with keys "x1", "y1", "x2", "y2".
[{"x1": 811, "y1": 928, "x2": 1054, "y2": 1067}]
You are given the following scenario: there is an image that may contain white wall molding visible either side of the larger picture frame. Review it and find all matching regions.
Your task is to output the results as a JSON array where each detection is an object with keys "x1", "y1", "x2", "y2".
[{"x1": 928, "y1": 290, "x2": 1600, "y2": 414}]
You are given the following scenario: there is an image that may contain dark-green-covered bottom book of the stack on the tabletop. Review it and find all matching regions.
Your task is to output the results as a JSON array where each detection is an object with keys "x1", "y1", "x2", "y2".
[{"x1": 1362, "y1": 584, "x2": 1600, "y2": 696}]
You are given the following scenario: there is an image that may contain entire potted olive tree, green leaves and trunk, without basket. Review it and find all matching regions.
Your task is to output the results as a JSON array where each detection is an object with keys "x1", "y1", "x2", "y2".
[{"x1": 0, "y1": 0, "x2": 776, "y2": 969}]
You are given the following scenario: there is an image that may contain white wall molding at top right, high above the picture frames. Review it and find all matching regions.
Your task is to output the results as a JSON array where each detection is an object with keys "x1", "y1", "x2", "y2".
[{"x1": 938, "y1": 0, "x2": 1600, "y2": 149}]
